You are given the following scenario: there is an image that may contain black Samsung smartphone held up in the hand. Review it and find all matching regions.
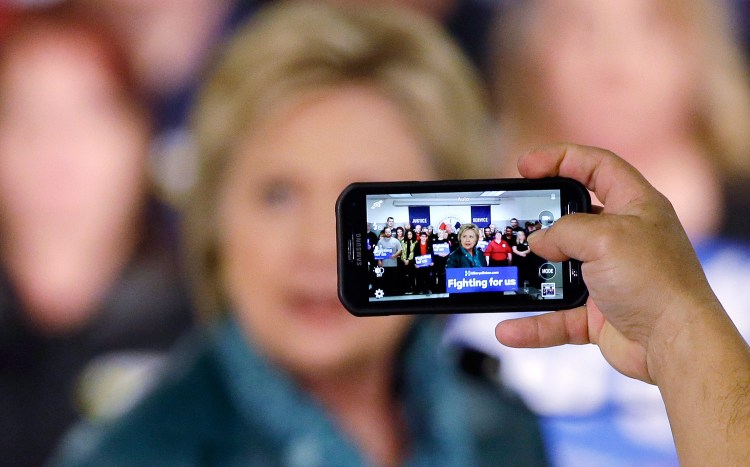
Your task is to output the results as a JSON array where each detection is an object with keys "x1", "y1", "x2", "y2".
[{"x1": 336, "y1": 178, "x2": 591, "y2": 316}]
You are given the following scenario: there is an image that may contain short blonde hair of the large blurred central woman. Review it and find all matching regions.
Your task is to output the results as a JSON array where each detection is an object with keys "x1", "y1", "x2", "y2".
[{"x1": 185, "y1": 2, "x2": 490, "y2": 315}]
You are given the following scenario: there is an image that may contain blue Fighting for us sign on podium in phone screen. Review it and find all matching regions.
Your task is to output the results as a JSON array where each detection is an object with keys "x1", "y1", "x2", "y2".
[{"x1": 445, "y1": 266, "x2": 518, "y2": 294}]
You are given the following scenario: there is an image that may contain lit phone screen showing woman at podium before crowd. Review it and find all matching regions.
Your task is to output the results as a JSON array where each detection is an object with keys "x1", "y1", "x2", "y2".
[{"x1": 366, "y1": 190, "x2": 565, "y2": 301}]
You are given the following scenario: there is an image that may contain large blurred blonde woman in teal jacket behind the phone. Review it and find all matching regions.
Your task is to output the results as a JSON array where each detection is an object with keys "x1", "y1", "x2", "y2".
[{"x1": 51, "y1": 2, "x2": 545, "y2": 465}]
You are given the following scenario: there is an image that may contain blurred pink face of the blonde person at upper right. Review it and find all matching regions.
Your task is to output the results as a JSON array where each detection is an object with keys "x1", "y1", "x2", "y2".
[{"x1": 533, "y1": 0, "x2": 700, "y2": 154}]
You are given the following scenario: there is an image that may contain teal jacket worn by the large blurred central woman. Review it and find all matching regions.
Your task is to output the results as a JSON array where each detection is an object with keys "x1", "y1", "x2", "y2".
[{"x1": 53, "y1": 320, "x2": 546, "y2": 467}]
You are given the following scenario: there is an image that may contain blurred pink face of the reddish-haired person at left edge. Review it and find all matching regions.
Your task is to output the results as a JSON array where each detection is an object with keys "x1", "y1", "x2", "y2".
[{"x1": 0, "y1": 30, "x2": 149, "y2": 249}]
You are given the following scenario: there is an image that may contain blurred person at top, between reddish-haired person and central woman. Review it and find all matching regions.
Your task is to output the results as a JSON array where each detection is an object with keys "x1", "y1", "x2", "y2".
[{"x1": 66, "y1": 0, "x2": 258, "y2": 207}]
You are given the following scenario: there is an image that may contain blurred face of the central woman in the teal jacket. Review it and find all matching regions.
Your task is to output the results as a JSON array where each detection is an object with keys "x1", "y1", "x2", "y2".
[{"x1": 219, "y1": 86, "x2": 434, "y2": 376}]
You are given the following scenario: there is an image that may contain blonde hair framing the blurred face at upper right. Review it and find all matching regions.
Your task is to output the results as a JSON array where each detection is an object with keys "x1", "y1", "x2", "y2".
[{"x1": 492, "y1": 0, "x2": 750, "y2": 178}]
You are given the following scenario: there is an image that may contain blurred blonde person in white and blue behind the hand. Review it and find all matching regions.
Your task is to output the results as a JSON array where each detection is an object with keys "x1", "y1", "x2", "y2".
[{"x1": 452, "y1": 0, "x2": 750, "y2": 466}]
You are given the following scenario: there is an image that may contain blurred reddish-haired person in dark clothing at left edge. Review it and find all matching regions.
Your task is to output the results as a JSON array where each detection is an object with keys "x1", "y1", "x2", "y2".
[{"x1": 0, "y1": 7, "x2": 191, "y2": 466}]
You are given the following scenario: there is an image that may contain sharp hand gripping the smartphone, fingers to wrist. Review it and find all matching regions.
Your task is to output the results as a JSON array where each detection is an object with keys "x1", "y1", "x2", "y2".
[{"x1": 496, "y1": 145, "x2": 722, "y2": 382}]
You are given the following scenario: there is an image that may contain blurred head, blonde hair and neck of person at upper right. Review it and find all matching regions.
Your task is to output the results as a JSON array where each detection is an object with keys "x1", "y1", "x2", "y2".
[{"x1": 494, "y1": 0, "x2": 750, "y2": 242}]
